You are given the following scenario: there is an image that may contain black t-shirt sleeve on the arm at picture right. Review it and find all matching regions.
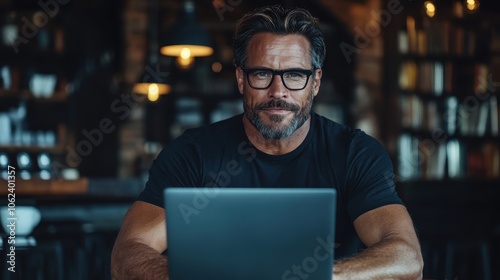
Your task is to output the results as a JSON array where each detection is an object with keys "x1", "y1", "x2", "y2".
[{"x1": 346, "y1": 132, "x2": 403, "y2": 221}]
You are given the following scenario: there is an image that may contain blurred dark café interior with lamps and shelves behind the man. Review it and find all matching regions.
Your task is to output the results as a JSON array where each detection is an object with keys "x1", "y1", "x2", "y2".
[{"x1": 0, "y1": 0, "x2": 500, "y2": 279}]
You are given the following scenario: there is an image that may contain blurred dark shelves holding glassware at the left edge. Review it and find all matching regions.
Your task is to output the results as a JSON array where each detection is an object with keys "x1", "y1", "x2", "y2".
[{"x1": 0, "y1": 9, "x2": 72, "y2": 181}]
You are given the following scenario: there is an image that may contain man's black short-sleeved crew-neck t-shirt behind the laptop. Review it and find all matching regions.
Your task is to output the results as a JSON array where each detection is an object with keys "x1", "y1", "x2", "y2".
[{"x1": 138, "y1": 113, "x2": 402, "y2": 258}]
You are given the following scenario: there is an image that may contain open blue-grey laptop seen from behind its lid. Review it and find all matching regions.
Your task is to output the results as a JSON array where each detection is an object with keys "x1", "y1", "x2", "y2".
[{"x1": 164, "y1": 188, "x2": 336, "y2": 280}]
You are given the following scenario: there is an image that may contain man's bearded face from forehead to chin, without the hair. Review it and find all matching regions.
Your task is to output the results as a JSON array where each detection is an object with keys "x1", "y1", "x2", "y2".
[{"x1": 236, "y1": 33, "x2": 322, "y2": 139}]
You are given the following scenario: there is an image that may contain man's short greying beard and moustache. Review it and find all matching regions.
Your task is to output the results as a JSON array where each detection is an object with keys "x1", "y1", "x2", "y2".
[{"x1": 243, "y1": 89, "x2": 314, "y2": 140}]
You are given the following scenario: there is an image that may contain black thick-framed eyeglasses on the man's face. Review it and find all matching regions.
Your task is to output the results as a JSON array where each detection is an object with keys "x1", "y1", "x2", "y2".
[{"x1": 241, "y1": 67, "x2": 315, "y2": 90}]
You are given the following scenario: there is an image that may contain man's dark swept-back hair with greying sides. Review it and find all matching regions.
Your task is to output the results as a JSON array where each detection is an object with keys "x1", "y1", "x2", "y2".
[{"x1": 233, "y1": 5, "x2": 326, "y2": 68}]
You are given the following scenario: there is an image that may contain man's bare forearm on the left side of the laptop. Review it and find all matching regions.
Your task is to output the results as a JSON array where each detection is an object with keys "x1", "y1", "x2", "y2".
[{"x1": 111, "y1": 240, "x2": 168, "y2": 280}]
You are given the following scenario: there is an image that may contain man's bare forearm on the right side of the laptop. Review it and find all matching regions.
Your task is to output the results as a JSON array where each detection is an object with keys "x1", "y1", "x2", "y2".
[{"x1": 333, "y1": 238, "x2": 423, "y2": 280}]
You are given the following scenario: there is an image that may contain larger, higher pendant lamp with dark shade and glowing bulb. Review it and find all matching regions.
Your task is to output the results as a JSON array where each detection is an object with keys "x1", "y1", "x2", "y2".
[{"x1": 160, "y1": 1, "x2": 213, "y2": 59}]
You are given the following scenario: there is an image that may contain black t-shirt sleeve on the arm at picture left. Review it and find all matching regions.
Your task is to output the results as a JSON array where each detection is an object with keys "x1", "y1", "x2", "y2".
[{"x1": 137, "y1": 133, "x2": 201, "y2": 208}]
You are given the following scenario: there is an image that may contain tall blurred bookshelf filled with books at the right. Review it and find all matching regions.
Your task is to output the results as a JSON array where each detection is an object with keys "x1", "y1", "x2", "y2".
[{"x1": 385, "y1": 1, "x2": 500, "y2": 183}]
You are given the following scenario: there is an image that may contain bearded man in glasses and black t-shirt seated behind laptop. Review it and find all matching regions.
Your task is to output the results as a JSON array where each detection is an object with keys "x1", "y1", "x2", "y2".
[{"x1": 112, "y1": 6, "x2": 423, "y2": 280}]
